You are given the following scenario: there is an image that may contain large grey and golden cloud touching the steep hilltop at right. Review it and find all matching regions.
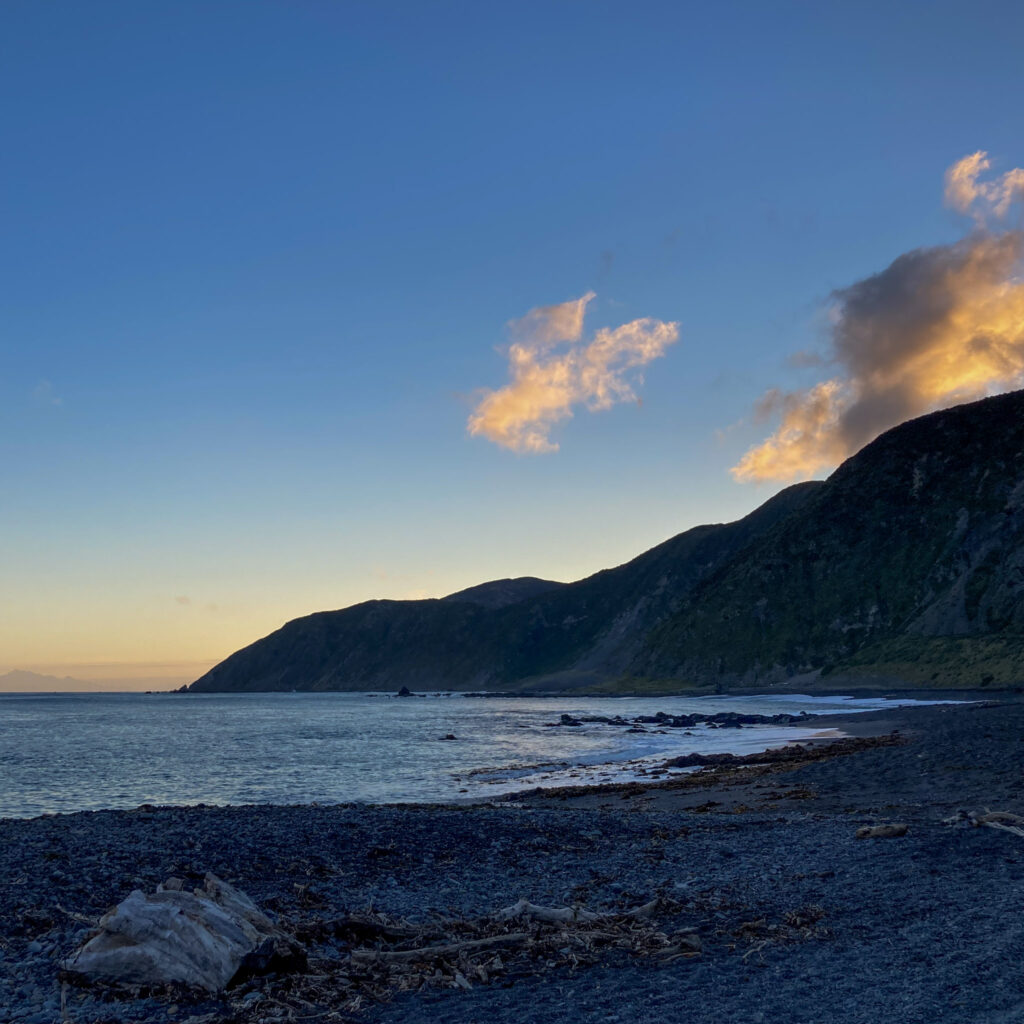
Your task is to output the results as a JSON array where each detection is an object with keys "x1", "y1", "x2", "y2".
[{"x1": 732, "y1": 153, "x2": 1024, "y2": 481}]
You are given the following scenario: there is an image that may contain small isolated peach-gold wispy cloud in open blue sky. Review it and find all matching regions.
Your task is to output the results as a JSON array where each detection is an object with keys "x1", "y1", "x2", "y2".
[{"x1": 467, "y1": 292, "x2": 679, "y2": 454}]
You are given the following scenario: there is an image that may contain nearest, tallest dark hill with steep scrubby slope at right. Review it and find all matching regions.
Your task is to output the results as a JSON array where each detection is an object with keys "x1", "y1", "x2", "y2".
[{"x1": 633, "y1": 391, "x2": 1024, "y2": 685}]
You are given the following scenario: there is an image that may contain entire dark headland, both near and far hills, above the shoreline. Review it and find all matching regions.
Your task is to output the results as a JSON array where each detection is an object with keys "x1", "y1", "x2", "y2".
[{"x1": 188, "y1": 391, "x2": 1024, "y2": 693}]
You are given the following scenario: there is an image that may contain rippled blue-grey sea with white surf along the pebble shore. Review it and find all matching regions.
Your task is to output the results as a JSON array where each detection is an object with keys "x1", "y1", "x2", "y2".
[{"x1": 0, "y1": 693, "x2": 942, "y2": 817}]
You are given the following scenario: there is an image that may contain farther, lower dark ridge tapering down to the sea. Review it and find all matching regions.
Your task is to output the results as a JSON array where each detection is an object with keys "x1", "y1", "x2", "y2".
[{"x1": 190, "y1": 483, "x2": 820, "y2": 691}]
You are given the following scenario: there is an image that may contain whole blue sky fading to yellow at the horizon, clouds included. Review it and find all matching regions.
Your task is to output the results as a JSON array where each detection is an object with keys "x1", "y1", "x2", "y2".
[{"x1": 0, "y1": 0, "x2": 1024, "y2": 686}]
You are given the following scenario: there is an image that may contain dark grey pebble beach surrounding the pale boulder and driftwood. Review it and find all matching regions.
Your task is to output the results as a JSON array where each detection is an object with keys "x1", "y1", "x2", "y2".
[{"x1": 0, "y1": 694, "x2": 1024, "y2": 1024}]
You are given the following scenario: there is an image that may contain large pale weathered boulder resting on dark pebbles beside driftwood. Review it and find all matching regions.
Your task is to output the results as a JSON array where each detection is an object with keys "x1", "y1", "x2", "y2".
[{"x1": 65, "y1": 874, "x2": 303, "y2": 992}]
